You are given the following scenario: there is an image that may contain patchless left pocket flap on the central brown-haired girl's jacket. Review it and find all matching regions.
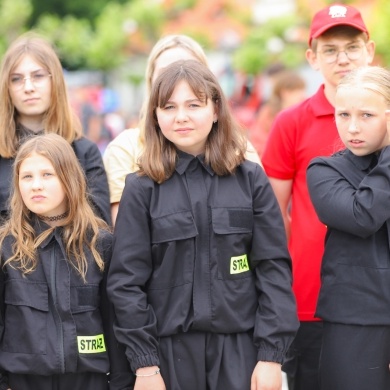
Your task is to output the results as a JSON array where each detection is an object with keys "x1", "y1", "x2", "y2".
[{"x1": 152, "y1": 211, "x2": 198, "y2": 244}]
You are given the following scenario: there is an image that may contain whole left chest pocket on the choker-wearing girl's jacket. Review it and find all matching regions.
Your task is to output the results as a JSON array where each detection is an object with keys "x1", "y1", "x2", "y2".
[{"x1": 1, "y1": 279, "x2": 49, "y2": 354}]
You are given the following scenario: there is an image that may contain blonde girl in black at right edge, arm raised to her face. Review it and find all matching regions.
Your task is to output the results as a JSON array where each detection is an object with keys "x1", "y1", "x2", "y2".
[{"x1": 307, "y1": 67, "x2": 390, "y2": 390}]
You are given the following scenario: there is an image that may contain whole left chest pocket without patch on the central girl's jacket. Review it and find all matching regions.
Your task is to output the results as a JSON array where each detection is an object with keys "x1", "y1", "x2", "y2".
[{"x1": 149, "y1": 211, "x2": 198, "y2": 289}]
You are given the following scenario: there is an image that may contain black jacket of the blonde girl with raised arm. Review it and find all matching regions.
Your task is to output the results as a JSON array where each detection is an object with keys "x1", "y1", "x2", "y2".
[{"x1": 307, "y1": 147, "x2": 390, "y2": 325}]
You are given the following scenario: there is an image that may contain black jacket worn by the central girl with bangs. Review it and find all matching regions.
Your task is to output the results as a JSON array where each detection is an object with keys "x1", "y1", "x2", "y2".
[{"x1": 108, "y1": 152, "x2": 298, "y2": 370}]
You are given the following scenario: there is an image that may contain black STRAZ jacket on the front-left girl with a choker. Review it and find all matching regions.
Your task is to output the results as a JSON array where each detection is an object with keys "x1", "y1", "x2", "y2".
[{"x1": 0, "y1": 221, "x2": 132, "y2": 389}]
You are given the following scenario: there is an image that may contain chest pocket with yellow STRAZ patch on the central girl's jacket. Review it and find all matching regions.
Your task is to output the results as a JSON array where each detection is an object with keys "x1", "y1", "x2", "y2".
[{"x1": 211, "y1": 207, "x2": 253, "y2": 280}]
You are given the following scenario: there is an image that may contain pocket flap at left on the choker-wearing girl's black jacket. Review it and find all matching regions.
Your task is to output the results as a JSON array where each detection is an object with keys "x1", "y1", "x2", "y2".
[{"x1": 5, "y1": 279, "x2": 49, "y2": 311}]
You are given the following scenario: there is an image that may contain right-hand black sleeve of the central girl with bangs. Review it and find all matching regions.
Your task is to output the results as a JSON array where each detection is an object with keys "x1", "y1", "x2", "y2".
[{"x1": 250, "y1": 167, "x2": 299, "y2": 363}]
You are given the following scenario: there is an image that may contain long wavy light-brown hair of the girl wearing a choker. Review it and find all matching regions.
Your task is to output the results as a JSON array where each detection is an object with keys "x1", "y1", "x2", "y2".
[{"x1": 0, "y1": 133, "x2": 109, "y2": 281}]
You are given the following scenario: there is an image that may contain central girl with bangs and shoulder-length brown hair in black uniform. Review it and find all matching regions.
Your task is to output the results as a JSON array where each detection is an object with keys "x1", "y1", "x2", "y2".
[{"x1": 108, "y1": 60, "x2": 298, "y2": 390}]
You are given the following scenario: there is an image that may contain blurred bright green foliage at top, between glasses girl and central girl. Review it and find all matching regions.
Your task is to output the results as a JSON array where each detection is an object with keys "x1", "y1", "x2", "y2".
[{"x1": 35, "y1": 0, "x2": 164, "y2": 70}]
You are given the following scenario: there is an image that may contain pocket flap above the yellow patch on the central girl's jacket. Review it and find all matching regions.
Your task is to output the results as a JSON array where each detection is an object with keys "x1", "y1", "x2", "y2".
[{"x1": 211, "y1": 207, "x2": 253, "y2": 234}]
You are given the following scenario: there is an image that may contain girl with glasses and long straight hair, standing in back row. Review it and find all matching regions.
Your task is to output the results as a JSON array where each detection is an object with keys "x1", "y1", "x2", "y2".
[{"x1": 0, "y1": 33, "x2": 111, "y2": 225}]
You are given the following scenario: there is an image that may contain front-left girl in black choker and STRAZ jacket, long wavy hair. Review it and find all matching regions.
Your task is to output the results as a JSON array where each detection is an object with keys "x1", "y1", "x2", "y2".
[{"x1": 0, "y1": 134, "x2": 132, "y2": 390}]
